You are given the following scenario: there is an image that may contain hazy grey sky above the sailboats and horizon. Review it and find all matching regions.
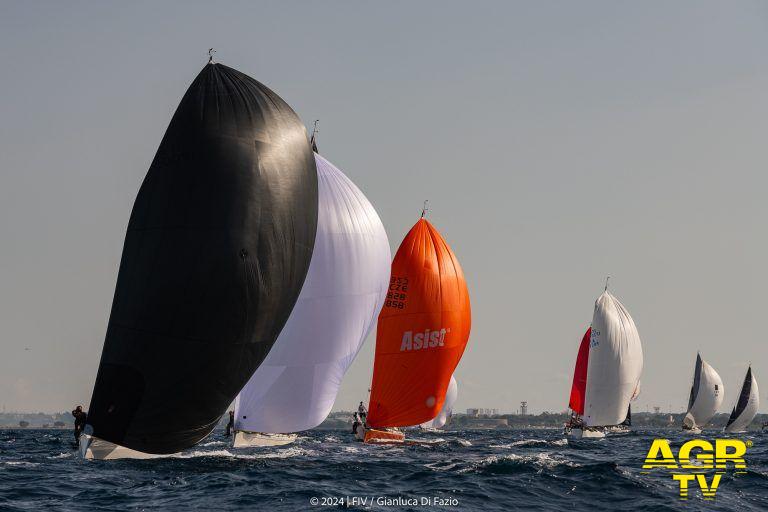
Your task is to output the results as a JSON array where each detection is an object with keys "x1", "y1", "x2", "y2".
[{"x1": 0, "y1": 0, "x2": 768, "y2": 411}]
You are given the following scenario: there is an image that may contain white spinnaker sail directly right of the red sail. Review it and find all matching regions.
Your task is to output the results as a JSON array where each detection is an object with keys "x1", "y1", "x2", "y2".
[{"x1": 584, "y1": 291, "x2": 643, "y2": 426}]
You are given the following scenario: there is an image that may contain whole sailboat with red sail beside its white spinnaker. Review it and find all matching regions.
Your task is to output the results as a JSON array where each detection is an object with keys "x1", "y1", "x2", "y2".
[{"x1": 566, "y1": 283, "x2": 643, "y2": 438}]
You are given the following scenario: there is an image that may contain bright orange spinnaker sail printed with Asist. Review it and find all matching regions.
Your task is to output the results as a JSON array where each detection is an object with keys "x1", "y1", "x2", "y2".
[{"x1": 367, "y1": 219, "x2": 472, "y2": 427}]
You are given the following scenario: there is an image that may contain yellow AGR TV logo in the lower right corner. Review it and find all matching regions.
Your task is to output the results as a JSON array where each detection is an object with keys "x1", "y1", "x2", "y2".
[{"x1": 642, "y1": 439, "x2": 752, "y2": 500}]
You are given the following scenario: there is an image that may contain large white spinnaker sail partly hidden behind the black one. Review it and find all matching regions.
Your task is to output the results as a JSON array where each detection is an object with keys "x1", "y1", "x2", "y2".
[{"x1": 235, "y1": 154, "x2": 392, "y2": 433}]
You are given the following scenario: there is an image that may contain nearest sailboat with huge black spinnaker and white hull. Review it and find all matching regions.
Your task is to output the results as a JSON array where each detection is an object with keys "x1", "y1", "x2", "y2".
[{"x1": 80, "y1": 59, "x2": 318, "y2": 459}]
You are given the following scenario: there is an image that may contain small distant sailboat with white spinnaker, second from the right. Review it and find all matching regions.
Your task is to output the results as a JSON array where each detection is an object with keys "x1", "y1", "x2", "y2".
[{"x1": 683, "y1": 353, "x2": 725, "y2": 434}]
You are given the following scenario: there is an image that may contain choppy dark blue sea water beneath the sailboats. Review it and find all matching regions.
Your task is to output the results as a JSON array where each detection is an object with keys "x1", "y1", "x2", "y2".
[{"x1": 0, "y1": 429, "x2": 768, "y2": 511}]
